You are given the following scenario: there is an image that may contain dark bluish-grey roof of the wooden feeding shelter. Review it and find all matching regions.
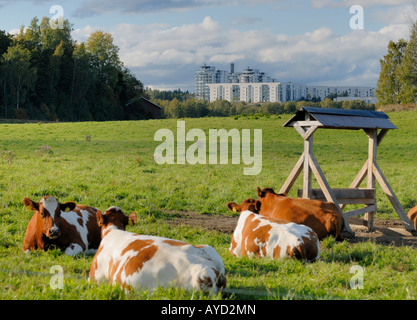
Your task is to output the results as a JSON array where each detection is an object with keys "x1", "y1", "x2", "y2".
[{"x1": 284, "y1": 107, "x2": 397, "y2": 130}]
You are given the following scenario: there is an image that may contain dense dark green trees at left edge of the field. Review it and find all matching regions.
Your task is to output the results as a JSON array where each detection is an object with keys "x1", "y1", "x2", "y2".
[{"x1": 0, "y1": 17, "x2": 147, "y2": 121}]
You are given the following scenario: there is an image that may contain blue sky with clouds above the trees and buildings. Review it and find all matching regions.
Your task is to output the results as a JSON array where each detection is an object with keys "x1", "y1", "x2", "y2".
[{"x1": 0, "y1": 0, "x2": 417, "y2": 92}]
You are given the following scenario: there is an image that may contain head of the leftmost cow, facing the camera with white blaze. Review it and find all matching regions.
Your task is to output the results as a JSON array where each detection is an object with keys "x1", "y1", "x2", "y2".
[{"x1": 23, "y1": 196, "x2": 76, "y2": 239}]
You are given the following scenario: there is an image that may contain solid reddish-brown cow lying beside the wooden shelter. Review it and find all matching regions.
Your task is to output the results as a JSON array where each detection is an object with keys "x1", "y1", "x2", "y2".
[{"x1": 257, "y1": 187, "x2": 345, "y2": 240}]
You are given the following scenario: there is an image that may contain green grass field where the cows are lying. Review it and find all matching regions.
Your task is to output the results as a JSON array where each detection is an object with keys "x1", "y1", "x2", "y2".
[{"x1": 0, "y1": 111, "x2": 417, "y2": 299}]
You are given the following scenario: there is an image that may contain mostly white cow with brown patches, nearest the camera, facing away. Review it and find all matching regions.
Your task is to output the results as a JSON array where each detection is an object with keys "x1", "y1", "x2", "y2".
[{"x1": 89, "y1": 207, "x2": 226, "y2": 293}]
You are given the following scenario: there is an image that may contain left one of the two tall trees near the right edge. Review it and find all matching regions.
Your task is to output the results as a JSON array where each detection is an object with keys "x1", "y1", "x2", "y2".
[{"x1": 376, "y1": 39, "x2": 407, "y2": 105}]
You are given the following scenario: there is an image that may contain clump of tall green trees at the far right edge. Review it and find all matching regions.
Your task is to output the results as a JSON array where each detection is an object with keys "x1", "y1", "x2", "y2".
[{"x1": 376, "y1": 21, "x2": 417, "y2": 106}]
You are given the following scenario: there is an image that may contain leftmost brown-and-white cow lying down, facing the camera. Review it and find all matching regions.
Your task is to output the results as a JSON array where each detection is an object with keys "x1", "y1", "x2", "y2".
[{"x1": 22, "y1": 196, "x2": 101, "y2": 256}]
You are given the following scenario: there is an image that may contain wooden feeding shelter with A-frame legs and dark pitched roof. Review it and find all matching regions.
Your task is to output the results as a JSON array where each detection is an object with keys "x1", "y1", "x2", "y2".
[{"x1": 280, "y1": 107, "x2": 415, "y2": 234}]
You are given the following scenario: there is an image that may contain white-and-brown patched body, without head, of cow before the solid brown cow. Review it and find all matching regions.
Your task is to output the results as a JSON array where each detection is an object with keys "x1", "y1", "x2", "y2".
[{"x1": 229, "y1": 210, "x2": 320, "y2": 261}]
